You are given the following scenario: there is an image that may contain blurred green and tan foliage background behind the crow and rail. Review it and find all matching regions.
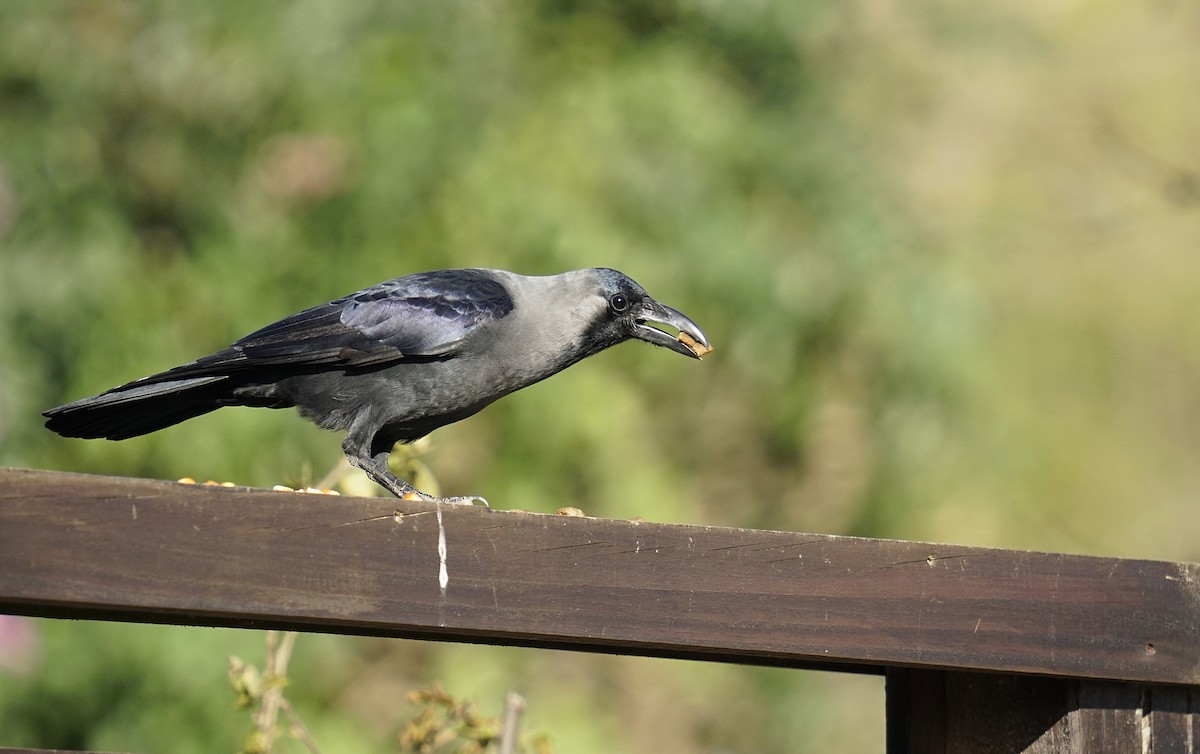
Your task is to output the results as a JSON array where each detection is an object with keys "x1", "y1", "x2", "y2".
[{"x1": 0, "y1": 0, "x2": 1200, "y2": 754}]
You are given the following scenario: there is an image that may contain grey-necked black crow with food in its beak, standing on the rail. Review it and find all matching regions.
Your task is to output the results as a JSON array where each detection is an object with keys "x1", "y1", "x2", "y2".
[{"x1": 43, "y1": 268, "x2": 712, "y2": 505}]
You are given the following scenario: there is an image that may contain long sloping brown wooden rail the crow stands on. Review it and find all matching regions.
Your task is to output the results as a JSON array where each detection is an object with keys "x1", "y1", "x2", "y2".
[{"x1": 0, "y1": 469, "x2": 1200, "y2": 681}]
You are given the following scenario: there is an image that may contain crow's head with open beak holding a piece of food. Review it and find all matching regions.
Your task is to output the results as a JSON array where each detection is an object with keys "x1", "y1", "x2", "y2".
[{"x1": 589, "y1": 268, "x2": 713, "y2": 359}]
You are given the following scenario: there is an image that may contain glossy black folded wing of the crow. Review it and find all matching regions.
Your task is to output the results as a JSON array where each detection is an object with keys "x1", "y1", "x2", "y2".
[{"x1": 148, "y1": 270, "x2": 512, "y2": 379}]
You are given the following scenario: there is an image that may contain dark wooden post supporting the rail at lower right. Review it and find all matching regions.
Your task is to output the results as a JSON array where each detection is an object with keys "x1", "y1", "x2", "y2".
[{"x1": 887, "y1": 669, "x2": 1200, "y2": 754}]
